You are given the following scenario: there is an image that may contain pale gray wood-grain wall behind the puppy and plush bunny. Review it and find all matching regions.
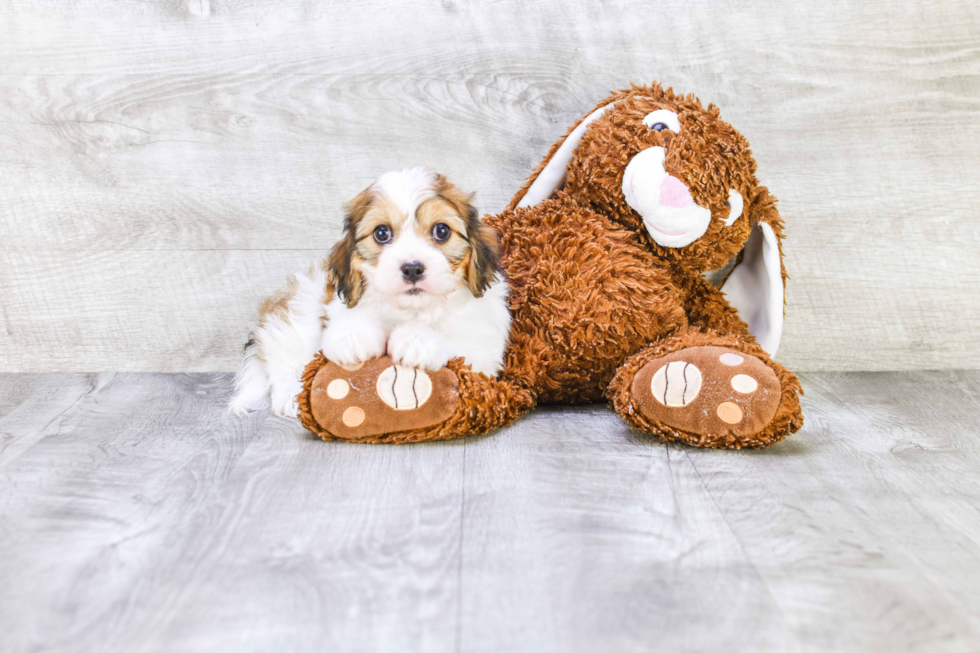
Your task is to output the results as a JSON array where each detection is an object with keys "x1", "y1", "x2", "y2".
[{"x1": 0, "y1": 0, "x2": 980, "y2": 371}]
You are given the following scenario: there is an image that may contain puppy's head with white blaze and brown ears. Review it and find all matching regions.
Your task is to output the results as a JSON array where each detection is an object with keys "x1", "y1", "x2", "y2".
[{"x1": 329, "y1": 168, "x2": 500, "y2": 309}]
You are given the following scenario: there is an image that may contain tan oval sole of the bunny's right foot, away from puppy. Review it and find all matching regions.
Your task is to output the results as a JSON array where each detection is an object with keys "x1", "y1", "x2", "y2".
[{"x1": 633, "y1": 346, "x2": 780, "y2": 436}]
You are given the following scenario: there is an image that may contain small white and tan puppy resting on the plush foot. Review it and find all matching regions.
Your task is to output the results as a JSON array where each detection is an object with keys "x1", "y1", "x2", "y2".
[{"x1": 230, "y1": 168, "x2": 510, "y2": 417}]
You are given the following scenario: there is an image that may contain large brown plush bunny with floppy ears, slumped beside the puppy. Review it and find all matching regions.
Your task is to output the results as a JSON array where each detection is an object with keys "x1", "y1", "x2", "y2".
[{"x1": 298, "y1": 83, "x2": 803, "y2": 449}]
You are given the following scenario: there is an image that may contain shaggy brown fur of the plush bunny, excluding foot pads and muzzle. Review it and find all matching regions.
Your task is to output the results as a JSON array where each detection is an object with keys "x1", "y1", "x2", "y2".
[{"x1": 300, "y1": 84, "x2": 803, "y2": 448}]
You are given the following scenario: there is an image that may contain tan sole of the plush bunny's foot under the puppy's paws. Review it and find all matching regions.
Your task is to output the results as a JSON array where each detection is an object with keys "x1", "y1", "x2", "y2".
[{"x1": 300, "y1": 356, "x2": 459, "y2": 440}]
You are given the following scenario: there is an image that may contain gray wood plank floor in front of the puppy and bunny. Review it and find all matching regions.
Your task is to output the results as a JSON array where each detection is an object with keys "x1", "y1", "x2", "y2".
[{"x1": 0, "y1": 371, "x2": 980, "y2": 653}]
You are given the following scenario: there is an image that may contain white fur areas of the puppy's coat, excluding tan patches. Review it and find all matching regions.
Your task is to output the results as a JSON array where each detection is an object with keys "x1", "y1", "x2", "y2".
[{"x1": 230, "y1": 168, "x2": 510, "y2": 417}]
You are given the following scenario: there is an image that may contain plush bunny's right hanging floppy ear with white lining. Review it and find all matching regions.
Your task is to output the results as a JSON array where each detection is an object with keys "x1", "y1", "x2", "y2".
[{"x1": 721, "y1": 186, "x2": 786, "y2": 356}]
